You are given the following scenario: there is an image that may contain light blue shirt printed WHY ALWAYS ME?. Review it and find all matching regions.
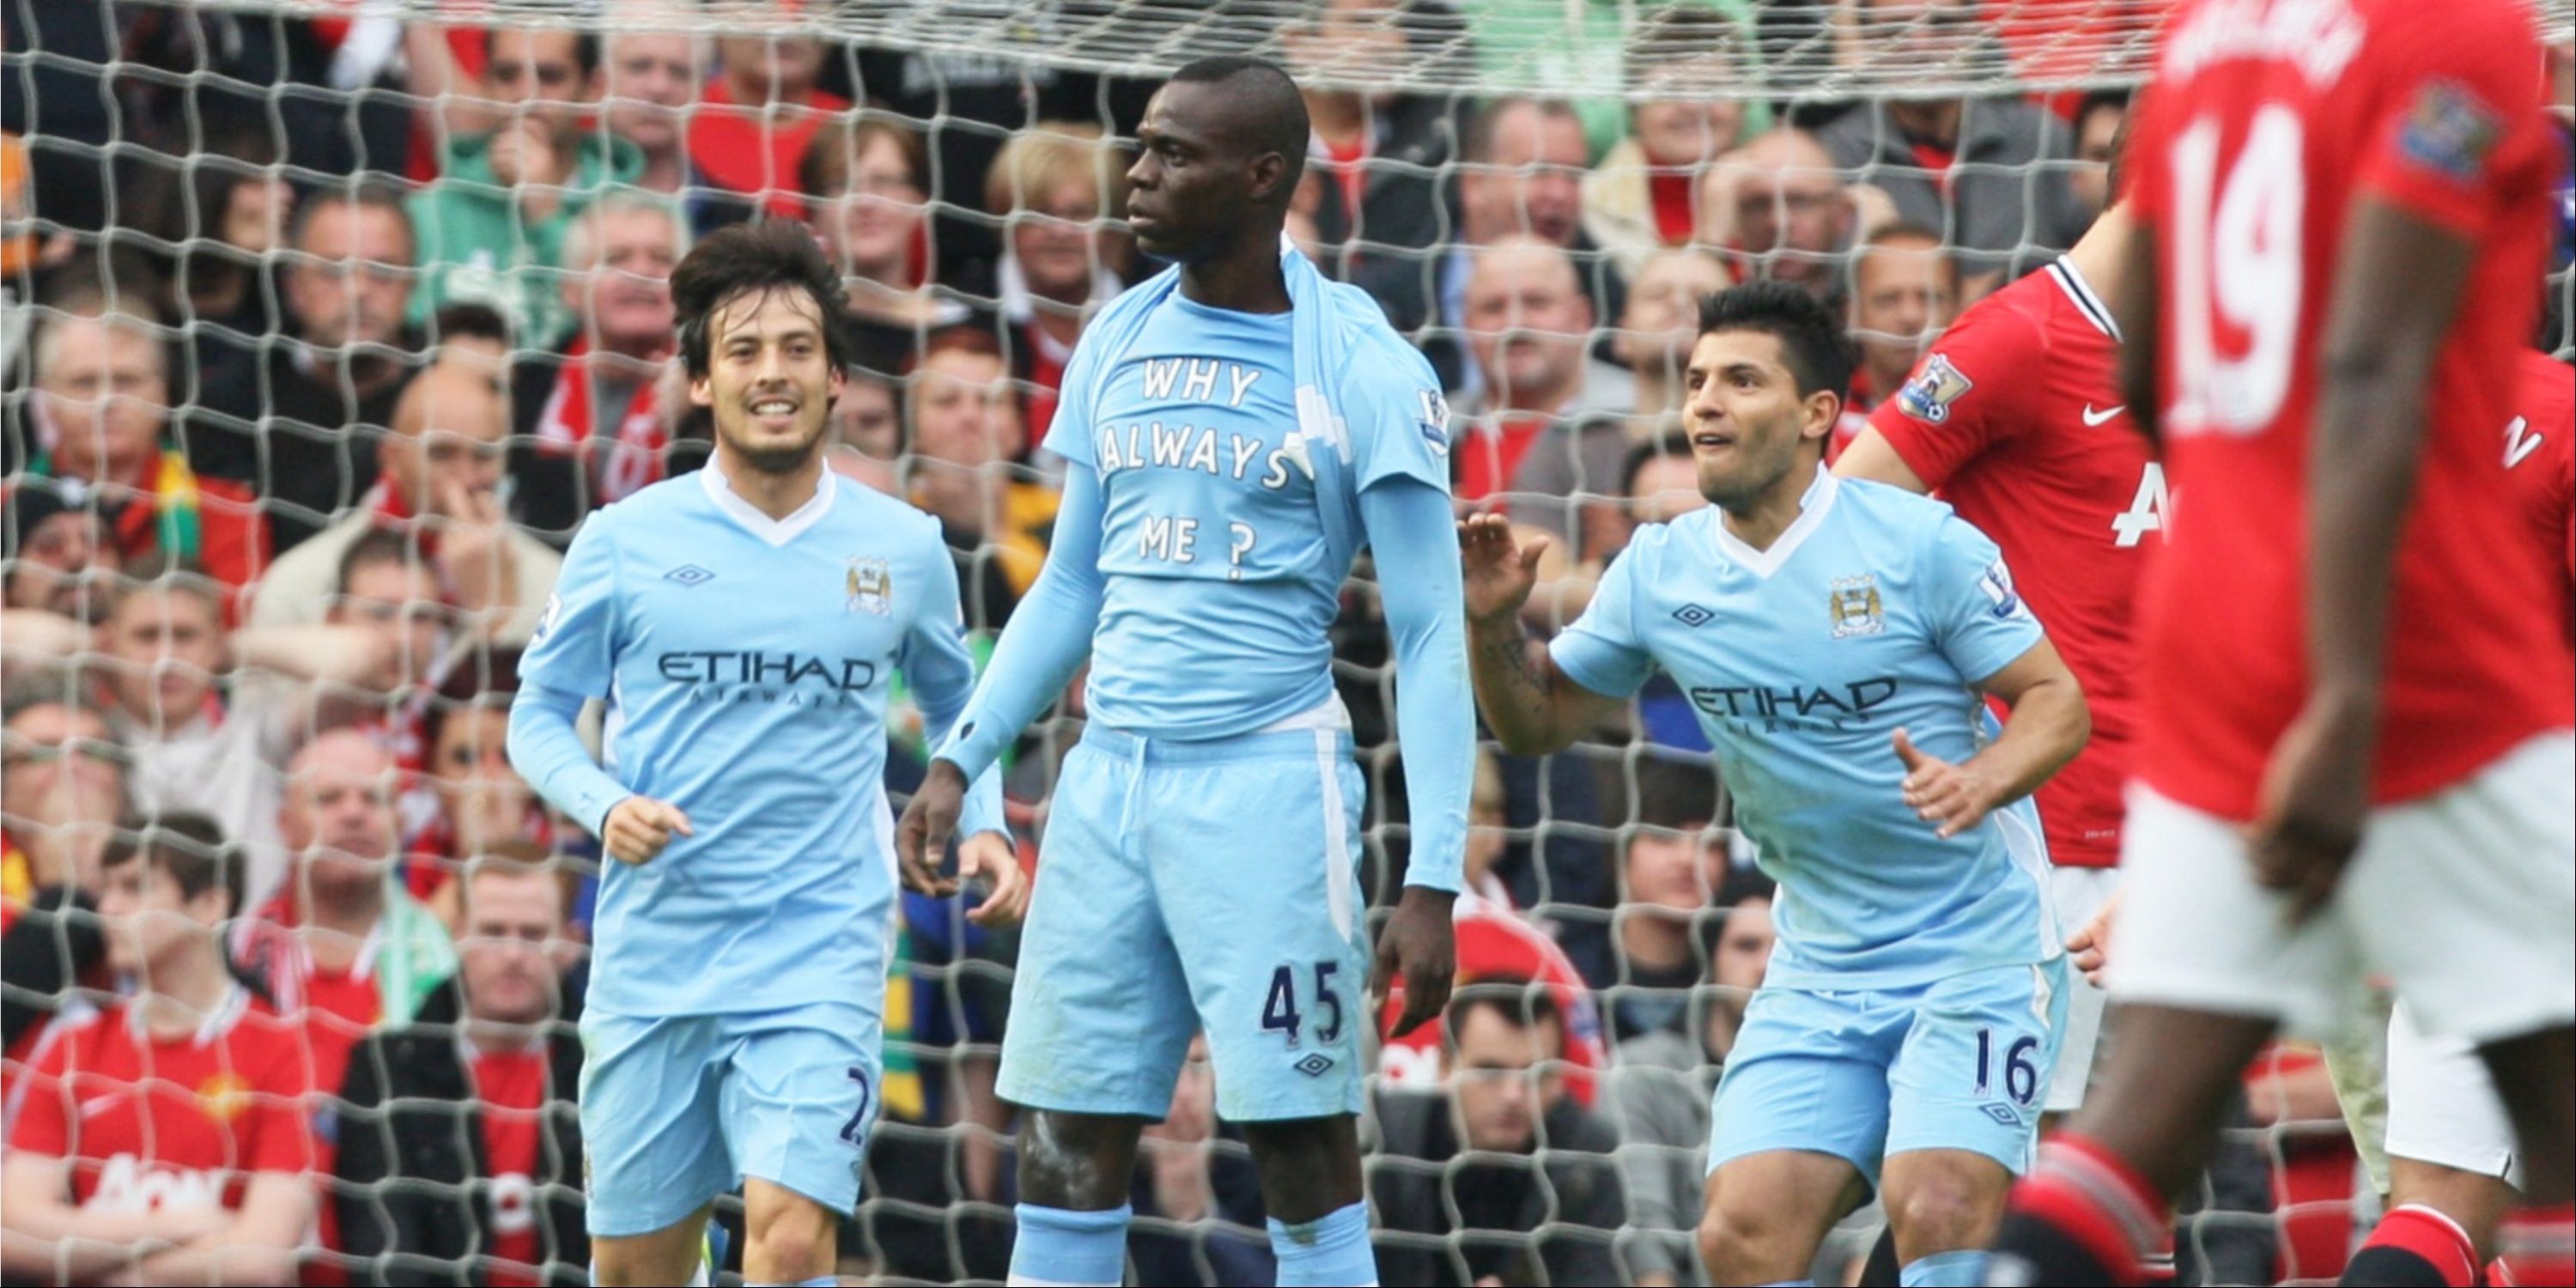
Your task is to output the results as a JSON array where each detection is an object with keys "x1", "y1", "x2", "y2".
[{"x1": 1046, "y1": 291, "x2": 1448, "y2": 739}]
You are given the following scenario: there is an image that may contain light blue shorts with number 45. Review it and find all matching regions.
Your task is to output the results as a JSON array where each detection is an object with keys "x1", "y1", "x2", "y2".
[{"x1": 999, "y1": 724, "x2": 1370, "y2": 1123}]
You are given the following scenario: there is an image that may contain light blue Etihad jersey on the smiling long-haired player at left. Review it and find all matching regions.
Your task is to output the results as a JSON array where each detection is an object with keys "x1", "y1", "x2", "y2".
[{"x1": 520, "y1": 464, "x2": 976, "y2": 1018}]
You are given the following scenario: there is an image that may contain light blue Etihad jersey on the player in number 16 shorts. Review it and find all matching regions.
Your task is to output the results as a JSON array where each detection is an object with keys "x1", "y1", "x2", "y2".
[{"x1": 1548, "y1": 471, "x2": 2063, "y2": 989}]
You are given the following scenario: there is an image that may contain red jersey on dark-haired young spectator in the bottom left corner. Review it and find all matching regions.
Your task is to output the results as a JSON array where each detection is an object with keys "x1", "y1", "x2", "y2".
[{"x1": 8, "y1": 987, "x2": 314, "y2": 1211}]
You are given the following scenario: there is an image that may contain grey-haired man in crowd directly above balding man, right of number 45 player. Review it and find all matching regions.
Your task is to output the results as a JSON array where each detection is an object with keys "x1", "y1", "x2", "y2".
[{"x1": 1432, "y1": 98, "x2": 1625, "y2": 399}]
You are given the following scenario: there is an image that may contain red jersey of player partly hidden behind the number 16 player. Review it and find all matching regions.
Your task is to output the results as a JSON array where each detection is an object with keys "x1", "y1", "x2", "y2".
[{"x1": 1870, "y1": 260, "x2": 2166, "y2": 868}]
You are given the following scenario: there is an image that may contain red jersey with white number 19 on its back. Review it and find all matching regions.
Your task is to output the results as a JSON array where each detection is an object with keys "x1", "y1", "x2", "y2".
[{"x1": 2130, "y1": 0, "x2": 2576, "y2": 819}]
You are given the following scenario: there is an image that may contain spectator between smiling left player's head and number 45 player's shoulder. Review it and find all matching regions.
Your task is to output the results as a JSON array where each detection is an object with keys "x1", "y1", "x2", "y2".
[{"x1": 904, "y1": 327, "x2": 1056, "y2": 631}]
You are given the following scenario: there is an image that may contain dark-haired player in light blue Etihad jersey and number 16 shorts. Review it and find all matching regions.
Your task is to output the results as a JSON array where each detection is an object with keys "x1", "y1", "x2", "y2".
[{"x1": 1461, "y1": 281, "x2": 2089, "y2": 1285}]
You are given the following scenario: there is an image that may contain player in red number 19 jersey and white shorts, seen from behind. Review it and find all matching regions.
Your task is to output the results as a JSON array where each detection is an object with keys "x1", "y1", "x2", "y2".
[{"x1": 1989, "y1": 0, "x2": 2576, "y2": 1285}]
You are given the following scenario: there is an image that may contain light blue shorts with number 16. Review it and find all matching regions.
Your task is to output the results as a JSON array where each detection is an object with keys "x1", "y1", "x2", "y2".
[{"x1": 1708, "y1": 958, "x2": 2066, "y2": 1190}]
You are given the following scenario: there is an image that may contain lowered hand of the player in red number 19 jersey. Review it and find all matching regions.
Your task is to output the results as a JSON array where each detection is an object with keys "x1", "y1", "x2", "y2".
[{"x1": 2249, "y1": 698, "x2": 2378, "y2": 922}]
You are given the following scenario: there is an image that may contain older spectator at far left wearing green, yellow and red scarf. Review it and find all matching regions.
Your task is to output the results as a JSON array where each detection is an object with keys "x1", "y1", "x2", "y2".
[{"x1": 26, "y1": 283, "x2": 268, "y2": 590}]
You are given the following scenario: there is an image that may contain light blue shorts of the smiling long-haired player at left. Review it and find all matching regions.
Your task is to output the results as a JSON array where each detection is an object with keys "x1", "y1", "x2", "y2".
[{"x1": 582, "y1": 1002, "x2": 884, "y2": 1239}]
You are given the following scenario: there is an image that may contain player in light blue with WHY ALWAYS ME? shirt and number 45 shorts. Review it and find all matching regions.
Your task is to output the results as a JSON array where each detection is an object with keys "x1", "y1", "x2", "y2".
[{"x1": 902, "y1": 59, "x2": 1476, "y2": 1285}]
